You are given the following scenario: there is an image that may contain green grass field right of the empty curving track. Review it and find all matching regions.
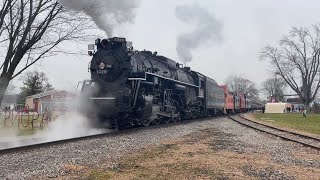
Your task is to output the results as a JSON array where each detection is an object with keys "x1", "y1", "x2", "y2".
[{"x1": 254, "y1": 113, "x2": 320, "y2": 135}]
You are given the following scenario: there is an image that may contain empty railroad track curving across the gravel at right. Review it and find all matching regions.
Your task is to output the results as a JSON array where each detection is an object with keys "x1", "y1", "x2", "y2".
[{"x1": 229, "y1": 115, "x2": 320, "y2": 150}]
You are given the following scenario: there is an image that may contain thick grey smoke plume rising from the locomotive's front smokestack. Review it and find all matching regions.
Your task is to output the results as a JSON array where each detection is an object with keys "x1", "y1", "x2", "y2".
[{"x1": 58, "y1": 0, "x2": 138, "y2": 37}]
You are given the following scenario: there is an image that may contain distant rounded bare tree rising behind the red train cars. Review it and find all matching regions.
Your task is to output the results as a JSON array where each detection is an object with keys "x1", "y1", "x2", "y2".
[{"x1": 226, "y1": 75, "x2": 259, "y2": 99}]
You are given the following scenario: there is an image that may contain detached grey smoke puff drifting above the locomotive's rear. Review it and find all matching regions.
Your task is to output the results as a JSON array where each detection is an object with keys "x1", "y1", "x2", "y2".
[{"x1": 176, "y1": 5, "x2": 222, "y2": 63}]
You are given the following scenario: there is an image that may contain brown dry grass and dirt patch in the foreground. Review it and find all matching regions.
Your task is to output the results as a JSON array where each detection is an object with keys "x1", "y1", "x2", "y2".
[{"x1": 58, "y1": 125, "x2": 320, "y2": 180}]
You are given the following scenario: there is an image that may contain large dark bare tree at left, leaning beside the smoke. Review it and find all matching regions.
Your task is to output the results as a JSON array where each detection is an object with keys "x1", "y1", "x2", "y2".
[{"x1": 0, "y1": 0, "x2": 90, "y2": 102}]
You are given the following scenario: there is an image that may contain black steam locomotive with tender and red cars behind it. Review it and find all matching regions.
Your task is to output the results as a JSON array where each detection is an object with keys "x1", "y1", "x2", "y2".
[{"x1": 82, "y1": 37, "x2": 249, "y2": 128}]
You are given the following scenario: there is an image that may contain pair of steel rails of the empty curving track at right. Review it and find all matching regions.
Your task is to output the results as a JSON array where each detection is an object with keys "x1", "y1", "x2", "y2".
[{"x1": 229, "y1": 115, "x2": 320, "y2": 150}]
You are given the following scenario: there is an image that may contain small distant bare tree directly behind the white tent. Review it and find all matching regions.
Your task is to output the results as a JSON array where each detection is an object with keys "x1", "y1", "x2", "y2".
[{"x1": 262, "y1": 76, "x2": 287, "y2": 102}]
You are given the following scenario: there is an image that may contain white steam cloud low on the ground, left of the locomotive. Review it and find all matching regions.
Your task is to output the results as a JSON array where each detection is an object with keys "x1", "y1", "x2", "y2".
[{"x1": 0, "y1": 85, "x2": 111, "y2": 150}]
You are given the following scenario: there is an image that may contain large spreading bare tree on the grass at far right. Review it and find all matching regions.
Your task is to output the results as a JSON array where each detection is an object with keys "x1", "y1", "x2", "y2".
[{"x1": 260, "y1": 25, "x2": 320, "y2": 108}]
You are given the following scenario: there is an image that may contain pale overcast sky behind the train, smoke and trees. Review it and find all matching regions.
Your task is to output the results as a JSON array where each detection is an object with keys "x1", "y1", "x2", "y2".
[{"x1": 15, "y1": 0, "x2": 320, "y2": 91}]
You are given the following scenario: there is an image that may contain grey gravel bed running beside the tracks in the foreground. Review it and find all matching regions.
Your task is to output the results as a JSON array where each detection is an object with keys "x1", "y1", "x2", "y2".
[{"x1": 0, "y1": 118, "x2": 320, "y2": 179}]
